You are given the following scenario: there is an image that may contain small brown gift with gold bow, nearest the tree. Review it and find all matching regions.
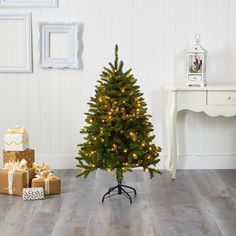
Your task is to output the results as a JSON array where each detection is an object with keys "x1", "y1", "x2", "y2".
[{"x1": 31, "y1": 171, "x2": 61, "y2": 195}]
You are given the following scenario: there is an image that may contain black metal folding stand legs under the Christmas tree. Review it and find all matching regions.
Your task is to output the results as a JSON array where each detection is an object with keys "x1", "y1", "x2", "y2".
[{"x1": 102, "y1": 182, "x2": 137, "y2": 204}]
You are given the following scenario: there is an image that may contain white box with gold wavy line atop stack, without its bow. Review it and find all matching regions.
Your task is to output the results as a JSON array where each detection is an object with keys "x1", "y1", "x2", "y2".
[{"x1": 4, "y1": 133, "x2": 29, "y2": 151}]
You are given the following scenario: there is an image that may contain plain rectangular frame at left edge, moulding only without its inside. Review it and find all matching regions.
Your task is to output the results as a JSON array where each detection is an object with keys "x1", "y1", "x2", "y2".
[{"x1": 0, "y1": 13, "x2": 32, "y2": 73}]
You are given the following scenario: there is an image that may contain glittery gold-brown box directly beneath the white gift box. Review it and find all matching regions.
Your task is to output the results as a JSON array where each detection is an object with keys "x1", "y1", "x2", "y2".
[{"x1": 3, "y1": 149, "x2": 35, "y2": 168}]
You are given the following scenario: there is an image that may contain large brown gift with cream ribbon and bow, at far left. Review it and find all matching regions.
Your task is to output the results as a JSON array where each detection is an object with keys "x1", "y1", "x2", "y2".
[{"x1": 0, "y1": 160, "x2": 35, "y2": 196}]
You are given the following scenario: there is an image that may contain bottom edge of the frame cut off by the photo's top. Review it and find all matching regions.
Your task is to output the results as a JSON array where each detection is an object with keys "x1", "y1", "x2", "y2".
[{"x1": 0, "y1": 0, "x2": 59, "y2": 7}]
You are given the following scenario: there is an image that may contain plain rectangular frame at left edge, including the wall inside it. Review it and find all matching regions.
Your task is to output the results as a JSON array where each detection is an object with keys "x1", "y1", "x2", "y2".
[{"x1": 0, "y1": 14, "x2": 32, "y2": 73}]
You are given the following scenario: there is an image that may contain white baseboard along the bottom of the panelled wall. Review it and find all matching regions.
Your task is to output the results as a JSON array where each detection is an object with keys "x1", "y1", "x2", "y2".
[{"x1": 29, "y1": 154, "x2": 236, "y2": 169}]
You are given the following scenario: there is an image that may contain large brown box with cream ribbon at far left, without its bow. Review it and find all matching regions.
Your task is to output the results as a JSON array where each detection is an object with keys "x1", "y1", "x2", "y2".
[{"x1": 0, "y1": 169, "x2": 35, "y2": 196}]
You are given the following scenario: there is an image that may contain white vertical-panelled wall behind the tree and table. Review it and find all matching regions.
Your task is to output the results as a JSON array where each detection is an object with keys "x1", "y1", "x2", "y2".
[{"x1": 0, "y1": 0, "x2": 236, "y2": 168}]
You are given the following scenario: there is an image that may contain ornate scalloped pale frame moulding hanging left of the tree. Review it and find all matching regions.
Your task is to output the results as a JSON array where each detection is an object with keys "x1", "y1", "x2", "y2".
[{"x1": 39, "y1": 22, "x2": 79, "y2": 69}]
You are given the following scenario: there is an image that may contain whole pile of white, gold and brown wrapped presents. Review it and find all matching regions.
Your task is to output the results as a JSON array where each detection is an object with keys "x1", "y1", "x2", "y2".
[{"x1": 0, "y1": 126, "x2": 61, "y2": 200}]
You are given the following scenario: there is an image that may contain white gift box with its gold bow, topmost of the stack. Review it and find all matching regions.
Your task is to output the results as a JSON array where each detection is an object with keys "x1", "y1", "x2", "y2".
[{"x1": 4, "y1": 126, "x2": 29, "y2": 151}]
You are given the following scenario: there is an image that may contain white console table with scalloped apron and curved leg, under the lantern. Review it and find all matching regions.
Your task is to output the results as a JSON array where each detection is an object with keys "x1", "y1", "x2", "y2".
[{"x1": 165, "y1": 84, "x2": 236, "y2": 179}]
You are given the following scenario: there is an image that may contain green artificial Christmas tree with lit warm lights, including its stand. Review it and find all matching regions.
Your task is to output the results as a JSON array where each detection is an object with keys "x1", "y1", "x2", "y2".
[{"x1": 76, "y1": 45, "x2": 161, "y2": 202}]
